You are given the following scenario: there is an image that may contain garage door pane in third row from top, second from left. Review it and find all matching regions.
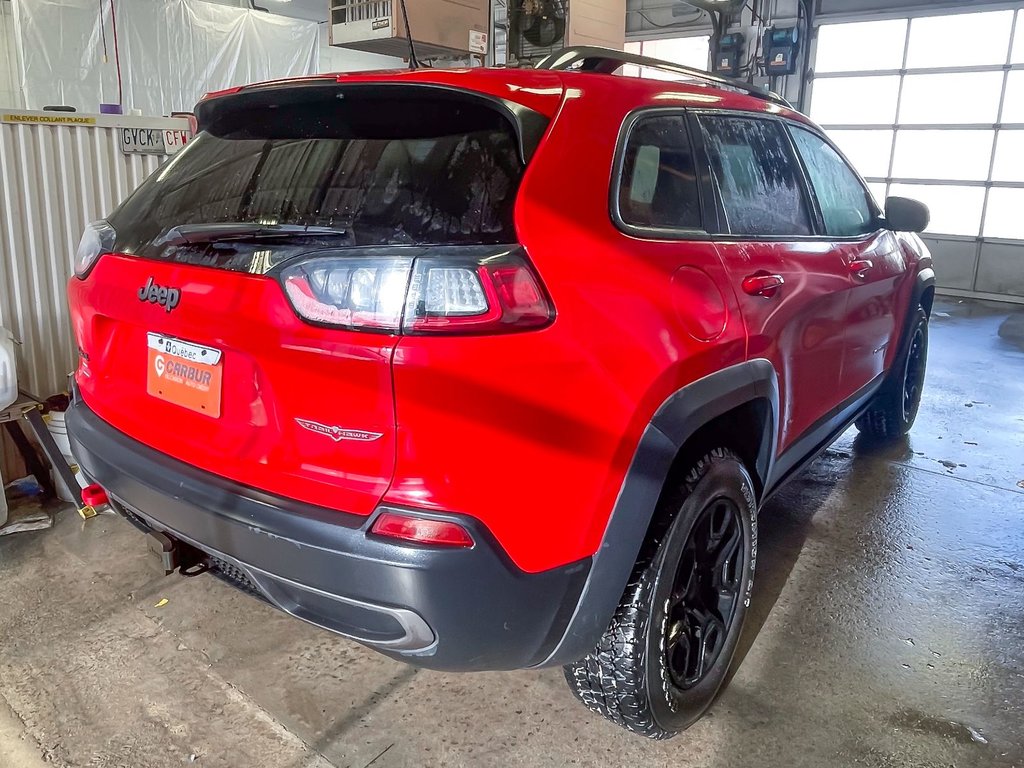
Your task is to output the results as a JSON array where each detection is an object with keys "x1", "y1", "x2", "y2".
[{"x1": 893, "y1": 130, "x2": 995, "y2": 181}]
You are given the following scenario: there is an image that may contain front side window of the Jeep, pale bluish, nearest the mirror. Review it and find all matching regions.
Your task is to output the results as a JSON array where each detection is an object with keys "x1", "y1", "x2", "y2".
[{"x1": 790, "y1": 127, "x2": 878, "y2": 238}]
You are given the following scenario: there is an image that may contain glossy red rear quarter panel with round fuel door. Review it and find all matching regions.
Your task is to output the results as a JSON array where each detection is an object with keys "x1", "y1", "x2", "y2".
[{"x1": 385, "y1": 81, "x2": 745, "y2": 572}]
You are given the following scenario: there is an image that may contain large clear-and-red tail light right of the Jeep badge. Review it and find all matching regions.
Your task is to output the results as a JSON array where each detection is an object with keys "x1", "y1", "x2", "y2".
[{"x1": 280, "y1": 247, "x2": 554, "y2": 334}]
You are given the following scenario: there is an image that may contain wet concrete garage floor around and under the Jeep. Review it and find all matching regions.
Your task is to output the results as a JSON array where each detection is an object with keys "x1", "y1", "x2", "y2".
[{"x1": 0, "y1": 301, "x2": 1024, "y2": 768}]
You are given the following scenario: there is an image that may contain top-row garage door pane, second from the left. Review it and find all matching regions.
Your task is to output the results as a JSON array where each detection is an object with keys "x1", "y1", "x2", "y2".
[{"x1": 909, "y1": 10, "x2": 1014, "y2": 70}]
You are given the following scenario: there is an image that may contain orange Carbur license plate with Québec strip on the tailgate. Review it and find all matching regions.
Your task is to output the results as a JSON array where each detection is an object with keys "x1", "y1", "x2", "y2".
[{"x1": 145, "y1": 334, "x2": 223, "y2": 419}]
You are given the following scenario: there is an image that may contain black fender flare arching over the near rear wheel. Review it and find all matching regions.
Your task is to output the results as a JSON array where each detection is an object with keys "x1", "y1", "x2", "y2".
[{"x1": 536, "y1": 359, "x2": 778, "y2": 667}]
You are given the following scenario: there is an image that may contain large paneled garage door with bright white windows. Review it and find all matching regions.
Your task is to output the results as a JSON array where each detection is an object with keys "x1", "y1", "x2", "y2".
[{"x1": 810, "y1": 9, "x2": 1024, "y2": 301}]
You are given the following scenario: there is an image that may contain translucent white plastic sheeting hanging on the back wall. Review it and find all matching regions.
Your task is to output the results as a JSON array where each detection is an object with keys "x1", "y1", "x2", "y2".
[{"x1": 13, "y1": 0, "x2": 317, "y2": 115}]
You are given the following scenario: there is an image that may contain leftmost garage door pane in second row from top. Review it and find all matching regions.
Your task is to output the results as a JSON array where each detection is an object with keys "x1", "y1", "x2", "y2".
[{"x1": 811, "y1": 75, "x2": 899, "y2": 125}]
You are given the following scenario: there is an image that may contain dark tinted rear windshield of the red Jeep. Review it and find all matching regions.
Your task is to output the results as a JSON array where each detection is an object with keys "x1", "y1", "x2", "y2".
[{"x1": 109, "y1": 89, "x2": 523, "y2": 271}]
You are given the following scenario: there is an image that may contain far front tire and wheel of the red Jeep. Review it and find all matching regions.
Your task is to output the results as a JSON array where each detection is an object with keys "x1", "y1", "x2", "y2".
[{"x1": 857, "y1": 307, "x2": 928, "y2": 442}]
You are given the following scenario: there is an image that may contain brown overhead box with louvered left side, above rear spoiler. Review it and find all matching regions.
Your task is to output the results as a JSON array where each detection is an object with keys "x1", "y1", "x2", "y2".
[{"x1": 329, "y1": 0, "x2": 489, "y2": 60}]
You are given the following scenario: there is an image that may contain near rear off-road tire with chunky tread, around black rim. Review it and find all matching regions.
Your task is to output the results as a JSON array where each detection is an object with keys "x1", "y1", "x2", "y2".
[{"x1": 564, "y1": 449, "x2": 757, "y2": 739}]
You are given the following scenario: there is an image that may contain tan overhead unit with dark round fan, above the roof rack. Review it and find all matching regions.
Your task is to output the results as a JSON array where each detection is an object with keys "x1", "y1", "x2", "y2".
[{"x1": 508, "y1": 0, "x2": 626, "y2": 65}]
